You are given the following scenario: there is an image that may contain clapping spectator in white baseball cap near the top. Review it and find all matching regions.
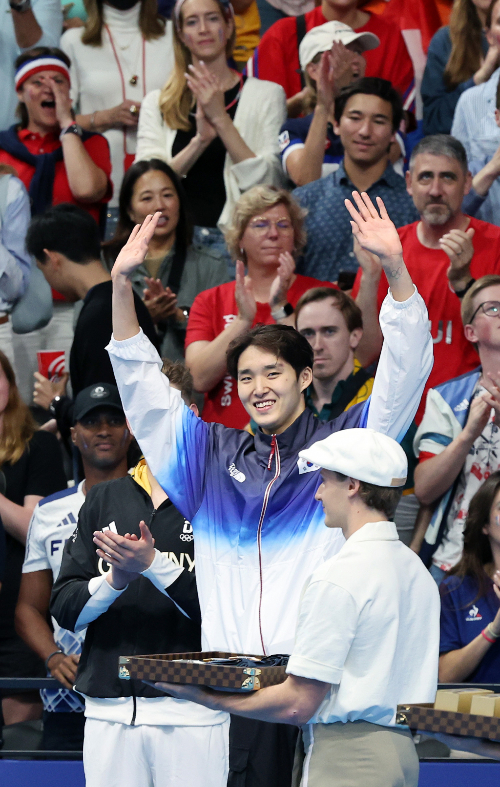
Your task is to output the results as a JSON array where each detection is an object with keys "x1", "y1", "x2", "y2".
[{"x1": 279, "y1": 21, "x2": 380, "y2": 186}]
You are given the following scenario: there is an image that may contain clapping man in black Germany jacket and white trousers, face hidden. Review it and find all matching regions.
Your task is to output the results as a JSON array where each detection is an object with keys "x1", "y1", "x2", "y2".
[{"x1": 51, "y1": 364, "x2": 227, "y2": 787}]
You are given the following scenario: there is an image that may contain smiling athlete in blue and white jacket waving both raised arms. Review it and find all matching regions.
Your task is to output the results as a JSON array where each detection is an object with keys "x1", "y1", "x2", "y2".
[{"x1": 102, "y1": 192, "x2": 432, "y2": 787}]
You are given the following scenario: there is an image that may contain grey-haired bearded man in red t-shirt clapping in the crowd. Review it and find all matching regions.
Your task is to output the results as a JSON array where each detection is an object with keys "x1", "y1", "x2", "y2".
[{"x1": 353, "y1": 134, "x2": 500, "y2": 423}]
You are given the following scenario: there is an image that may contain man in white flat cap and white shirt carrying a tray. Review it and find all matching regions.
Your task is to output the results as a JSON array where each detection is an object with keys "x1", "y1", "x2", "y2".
[{"x1": 156, "y1": 429, "x2": 440, "y2": 787}]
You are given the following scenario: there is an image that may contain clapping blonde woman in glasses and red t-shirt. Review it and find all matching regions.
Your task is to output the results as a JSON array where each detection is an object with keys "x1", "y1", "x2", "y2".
[{"x1": 186, "y1": 186, "x2": 337, "y2": 429}]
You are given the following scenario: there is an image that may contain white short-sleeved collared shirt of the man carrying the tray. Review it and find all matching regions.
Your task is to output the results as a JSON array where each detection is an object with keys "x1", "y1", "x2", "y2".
[{"x1": 287, "y1": 522, "x2": 440, "y2": 726}]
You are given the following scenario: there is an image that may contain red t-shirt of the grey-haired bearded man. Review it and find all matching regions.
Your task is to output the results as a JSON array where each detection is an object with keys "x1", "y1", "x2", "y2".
[{"x1": 352, "y1": 218, "x2": 500, "y2": 423}]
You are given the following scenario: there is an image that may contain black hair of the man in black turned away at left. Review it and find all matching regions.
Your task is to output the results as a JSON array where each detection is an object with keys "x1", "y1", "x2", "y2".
[{"x1": 26, "y1": 202, "x2": 101, "y2": 265}]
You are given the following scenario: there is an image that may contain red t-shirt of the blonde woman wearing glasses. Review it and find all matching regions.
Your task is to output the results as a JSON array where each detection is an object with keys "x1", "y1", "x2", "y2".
[{"x1": 186, "y1": 275, "x2": 338, "y2": 429}]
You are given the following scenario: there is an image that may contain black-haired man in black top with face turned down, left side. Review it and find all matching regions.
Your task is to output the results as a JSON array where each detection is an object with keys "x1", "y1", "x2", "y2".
[{"x1": 26, "y1": 203, "x2": 159, "y2": 438}]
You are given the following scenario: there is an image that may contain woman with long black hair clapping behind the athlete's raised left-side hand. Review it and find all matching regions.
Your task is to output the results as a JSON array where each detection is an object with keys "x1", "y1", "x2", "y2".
[{"x1": 103, "y1": 159, "x2": 228, "y2": 360}]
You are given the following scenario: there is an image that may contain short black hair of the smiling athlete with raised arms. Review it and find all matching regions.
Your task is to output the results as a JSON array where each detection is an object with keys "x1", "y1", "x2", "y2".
[{"x1": 227, "y1": 325, "x2": 314, "y2": 379}]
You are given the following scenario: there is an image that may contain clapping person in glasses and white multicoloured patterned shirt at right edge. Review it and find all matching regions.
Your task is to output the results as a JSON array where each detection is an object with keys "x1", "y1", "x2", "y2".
[{"x1": 414, "y1": 275, "x2": 500, "y2": 584}]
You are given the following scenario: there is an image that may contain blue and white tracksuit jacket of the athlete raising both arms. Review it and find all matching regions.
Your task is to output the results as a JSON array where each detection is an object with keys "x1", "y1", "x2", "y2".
[{"x1": 108, "y1": 291, "x2": 433, "y2": 654}]
